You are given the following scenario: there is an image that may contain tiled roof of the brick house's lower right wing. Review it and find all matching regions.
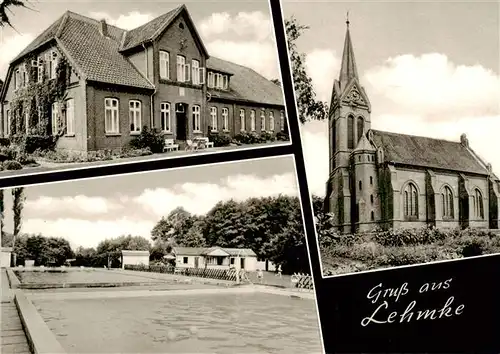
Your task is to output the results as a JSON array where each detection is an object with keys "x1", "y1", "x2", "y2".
[{"x1": 207, "y1": 57, "x2": 284, "y2": 106}]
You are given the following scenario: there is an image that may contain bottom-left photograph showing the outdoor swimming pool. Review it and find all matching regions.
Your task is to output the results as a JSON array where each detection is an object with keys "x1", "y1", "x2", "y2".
[{"x1": 0, "y1": 156, "x2": 323, "y2": 354}]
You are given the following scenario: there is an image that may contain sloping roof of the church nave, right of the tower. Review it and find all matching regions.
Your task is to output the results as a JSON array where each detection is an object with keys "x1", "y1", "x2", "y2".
[{"x1": 372, "y1": 130, "x2": 488, "y2": 175}]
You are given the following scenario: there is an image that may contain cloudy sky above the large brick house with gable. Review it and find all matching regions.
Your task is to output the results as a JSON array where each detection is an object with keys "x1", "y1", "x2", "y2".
[{"x1": 0, "y1": 0, "x2": 280, "y2": 80}]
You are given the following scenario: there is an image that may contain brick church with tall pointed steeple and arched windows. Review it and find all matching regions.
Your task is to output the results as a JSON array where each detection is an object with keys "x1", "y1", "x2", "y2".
[{"x1": 325, "y1": 21, "x2": 500, "y2": 233}]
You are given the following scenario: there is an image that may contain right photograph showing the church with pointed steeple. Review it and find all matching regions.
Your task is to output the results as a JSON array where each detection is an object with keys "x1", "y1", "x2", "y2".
[{"x1": 283, "y1": 1, "x2": 500, "y2": 277}]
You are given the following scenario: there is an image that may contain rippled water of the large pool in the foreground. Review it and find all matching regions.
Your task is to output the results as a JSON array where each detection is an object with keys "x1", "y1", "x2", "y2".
[{"x1": 34, "y1": 293, "x2": 322, "y2": 354}]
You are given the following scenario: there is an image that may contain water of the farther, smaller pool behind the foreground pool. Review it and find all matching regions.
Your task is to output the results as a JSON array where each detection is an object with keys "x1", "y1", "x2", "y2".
[{"x1": 15, "y1": 269, "x2": 161, "y2": 284}]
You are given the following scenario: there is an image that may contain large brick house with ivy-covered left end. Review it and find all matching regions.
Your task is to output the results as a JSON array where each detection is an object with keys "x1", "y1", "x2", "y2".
[{"x1": 0, "y1": 5, "x2": 287, "y2": 151}]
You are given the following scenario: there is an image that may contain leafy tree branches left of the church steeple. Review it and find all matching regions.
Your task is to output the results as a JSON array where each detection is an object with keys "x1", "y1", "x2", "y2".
[{"x1": 285, "y1": 17, "x2": 328, "y2": 123}]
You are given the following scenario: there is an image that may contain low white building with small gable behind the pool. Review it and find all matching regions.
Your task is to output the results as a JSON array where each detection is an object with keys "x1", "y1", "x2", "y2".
[{"x1": 173, "y1": 247, "x2": 257, "y2": 272}]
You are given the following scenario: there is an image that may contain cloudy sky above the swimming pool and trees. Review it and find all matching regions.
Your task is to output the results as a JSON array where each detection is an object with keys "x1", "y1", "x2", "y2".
[{"x1": 1, "y1": 156, "x2": 298, "y2": 247}]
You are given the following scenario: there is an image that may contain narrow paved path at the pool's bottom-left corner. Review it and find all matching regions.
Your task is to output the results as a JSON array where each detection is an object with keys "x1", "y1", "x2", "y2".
[{"x1": 0, "y1": 269, "x2": 31, "y2": 354}]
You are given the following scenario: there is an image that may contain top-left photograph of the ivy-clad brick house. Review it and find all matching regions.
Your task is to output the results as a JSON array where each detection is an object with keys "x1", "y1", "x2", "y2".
[{"x1": 0, "y1": 0, "x2": 290, "y2": 178}]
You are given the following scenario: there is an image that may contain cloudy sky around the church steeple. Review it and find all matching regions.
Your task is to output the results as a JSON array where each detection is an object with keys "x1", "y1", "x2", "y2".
[{"x1": 282, "y1": 0, "x2": 500, "y2": 195}]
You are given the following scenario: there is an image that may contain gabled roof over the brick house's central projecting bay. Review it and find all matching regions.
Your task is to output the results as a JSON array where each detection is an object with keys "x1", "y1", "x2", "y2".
[{"x1": 120, "y1": 5, "x2": 208, "y2": 56}]
